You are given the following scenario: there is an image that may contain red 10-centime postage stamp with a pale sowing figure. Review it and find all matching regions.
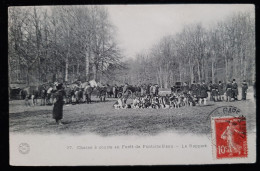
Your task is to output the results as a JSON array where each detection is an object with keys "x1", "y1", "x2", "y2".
[{"x1": 211, "y1": 116, "x2": 247, "y2": 159}]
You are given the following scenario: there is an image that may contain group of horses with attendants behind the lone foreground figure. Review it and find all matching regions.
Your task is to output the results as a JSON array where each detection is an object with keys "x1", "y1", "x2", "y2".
[{"x1": 14, "y1": 80, "x2": 136, "y2": 106}]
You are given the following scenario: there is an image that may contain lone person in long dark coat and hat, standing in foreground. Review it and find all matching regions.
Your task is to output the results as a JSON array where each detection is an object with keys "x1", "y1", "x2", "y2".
[{"x1": 52, "y1": 83, "x2": 65, "y2": 125}]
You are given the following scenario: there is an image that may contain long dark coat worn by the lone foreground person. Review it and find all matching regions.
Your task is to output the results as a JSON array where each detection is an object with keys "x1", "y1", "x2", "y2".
[{"x1": 52, "y1": 90, "x2": 65, "y2": 120}]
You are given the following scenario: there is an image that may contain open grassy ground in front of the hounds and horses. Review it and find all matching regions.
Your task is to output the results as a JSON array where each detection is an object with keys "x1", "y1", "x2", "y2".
[{"x1": 9, "y1": 88, "x2": 256, "y2": 136}]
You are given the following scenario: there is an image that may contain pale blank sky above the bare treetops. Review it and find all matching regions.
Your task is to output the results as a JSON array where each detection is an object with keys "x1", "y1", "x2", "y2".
[{"x1": 107, "y1": 4, "x2": 255, "y2": 59}]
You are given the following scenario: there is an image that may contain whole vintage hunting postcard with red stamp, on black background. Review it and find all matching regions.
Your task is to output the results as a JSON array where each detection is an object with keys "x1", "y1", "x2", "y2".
[{"x1": 8, "y1": 4, "x2": 256, "y2": 166}]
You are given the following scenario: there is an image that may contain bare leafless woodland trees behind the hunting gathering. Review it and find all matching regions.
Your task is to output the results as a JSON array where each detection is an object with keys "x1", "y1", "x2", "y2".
[{"x1": 8, "y1": 6, "x2": 255, "y2": 88}]
